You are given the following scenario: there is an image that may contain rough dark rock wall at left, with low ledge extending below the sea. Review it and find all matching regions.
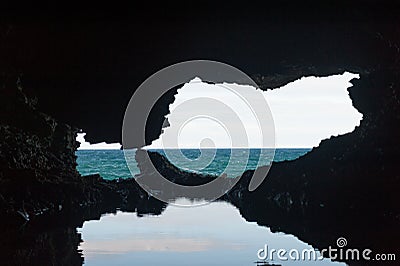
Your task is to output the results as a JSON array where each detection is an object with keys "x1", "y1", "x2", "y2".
[{"x1": 0, "y1": 77, "x2": 162, "y2": 228}]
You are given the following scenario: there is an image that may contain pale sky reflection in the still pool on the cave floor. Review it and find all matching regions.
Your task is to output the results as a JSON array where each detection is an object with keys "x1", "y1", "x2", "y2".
[{"x1": 78, "y1": 199, "x2": 344, "y2": 265}]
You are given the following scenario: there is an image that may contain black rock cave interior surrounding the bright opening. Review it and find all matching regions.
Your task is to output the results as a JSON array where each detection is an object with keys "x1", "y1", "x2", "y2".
[{"x1": 0, "y1": 1, "x2": 400, "y2": 265}]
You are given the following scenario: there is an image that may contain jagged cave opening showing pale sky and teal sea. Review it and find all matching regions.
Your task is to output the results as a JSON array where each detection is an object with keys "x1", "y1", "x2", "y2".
[{"x1": 76, "y1": 72, "x2": 363, "y2": 179}]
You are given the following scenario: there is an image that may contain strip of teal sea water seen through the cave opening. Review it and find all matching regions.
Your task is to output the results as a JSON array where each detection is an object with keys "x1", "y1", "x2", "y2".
[{"x1": 76, "y1": 149, "x2": 311, "y2": 180}]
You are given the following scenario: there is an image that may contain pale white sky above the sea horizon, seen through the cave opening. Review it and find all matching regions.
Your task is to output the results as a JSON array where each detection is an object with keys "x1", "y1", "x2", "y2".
[{"x1": 79, "y1": 72, "x2": 362, "y2": 149}]
